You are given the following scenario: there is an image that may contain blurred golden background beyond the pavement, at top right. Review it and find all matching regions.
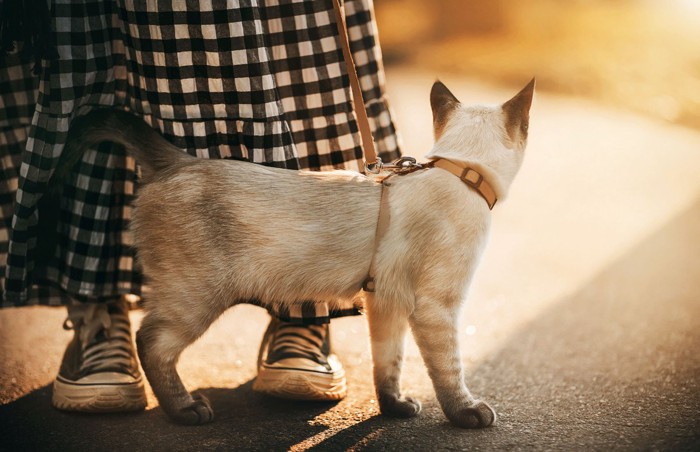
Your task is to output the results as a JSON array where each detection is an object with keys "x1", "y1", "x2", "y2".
[{"x1": 375, "y1": 0, "x2": 700, "y2": 128}]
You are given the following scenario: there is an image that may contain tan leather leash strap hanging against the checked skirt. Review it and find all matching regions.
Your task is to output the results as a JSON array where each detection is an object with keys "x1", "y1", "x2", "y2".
[{"x1": 333, "y1": 0, "x2": 379, "y2": 172}]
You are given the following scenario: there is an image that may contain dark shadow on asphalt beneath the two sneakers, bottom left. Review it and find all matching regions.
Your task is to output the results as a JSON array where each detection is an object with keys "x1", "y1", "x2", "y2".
[{"x1": 0, "y1": 380, "x2": 348, "y2": 450}]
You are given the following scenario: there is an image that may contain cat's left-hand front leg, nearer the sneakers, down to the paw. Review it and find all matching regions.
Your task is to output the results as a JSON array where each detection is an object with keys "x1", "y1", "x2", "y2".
[{"x1": 367, "y1": 300, "x2": 421, "y2": 418}]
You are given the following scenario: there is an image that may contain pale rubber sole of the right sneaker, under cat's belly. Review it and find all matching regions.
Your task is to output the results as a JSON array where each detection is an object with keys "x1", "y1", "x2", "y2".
[{"x1": 253, "y1": 365, "x2": 348, "y2": 401}]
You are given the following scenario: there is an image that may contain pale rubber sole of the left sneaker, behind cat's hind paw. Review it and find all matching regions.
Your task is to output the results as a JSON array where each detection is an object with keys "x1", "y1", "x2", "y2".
[{"x1": 51, "y1": 380, "x2": 146, "y2": 413}]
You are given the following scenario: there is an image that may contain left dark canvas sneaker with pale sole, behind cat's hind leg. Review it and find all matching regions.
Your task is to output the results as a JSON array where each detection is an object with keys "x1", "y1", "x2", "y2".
[{"x1": 51, "y1": 299, "x2": 146, "y2": 413}]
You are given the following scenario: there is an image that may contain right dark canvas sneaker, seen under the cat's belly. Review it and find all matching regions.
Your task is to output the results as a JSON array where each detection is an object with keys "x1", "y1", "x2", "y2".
[{"x1": 253, "y1": 319, "x2": 347, "y2": 401}]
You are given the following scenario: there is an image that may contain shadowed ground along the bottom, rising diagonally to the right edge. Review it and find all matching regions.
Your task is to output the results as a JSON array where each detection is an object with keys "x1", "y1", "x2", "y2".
[{"x1": 0, "y1": 200, "x2": 700, "y2": 450}]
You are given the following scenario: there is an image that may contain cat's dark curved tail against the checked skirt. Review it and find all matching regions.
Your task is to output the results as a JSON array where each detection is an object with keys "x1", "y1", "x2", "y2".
[{"x1": 50, "y1": 108, "x2": 194, "y2": 187}]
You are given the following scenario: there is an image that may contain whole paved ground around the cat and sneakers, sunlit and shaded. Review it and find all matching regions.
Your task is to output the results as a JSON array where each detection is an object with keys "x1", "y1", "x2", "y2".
[{"x1": 0, "y1": 70, "x2": 700, "y2": 451}]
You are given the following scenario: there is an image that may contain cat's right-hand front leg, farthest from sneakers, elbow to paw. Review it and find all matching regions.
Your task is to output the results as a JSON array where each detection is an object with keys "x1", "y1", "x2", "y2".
[{"x1": 410, "y1": 297, "x2": 496, "y2": 428}]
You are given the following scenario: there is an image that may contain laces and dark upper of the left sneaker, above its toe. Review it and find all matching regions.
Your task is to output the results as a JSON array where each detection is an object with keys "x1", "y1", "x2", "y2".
[{"x1": 63, "y1": 303, "x2": 132, "y2": 374}]
